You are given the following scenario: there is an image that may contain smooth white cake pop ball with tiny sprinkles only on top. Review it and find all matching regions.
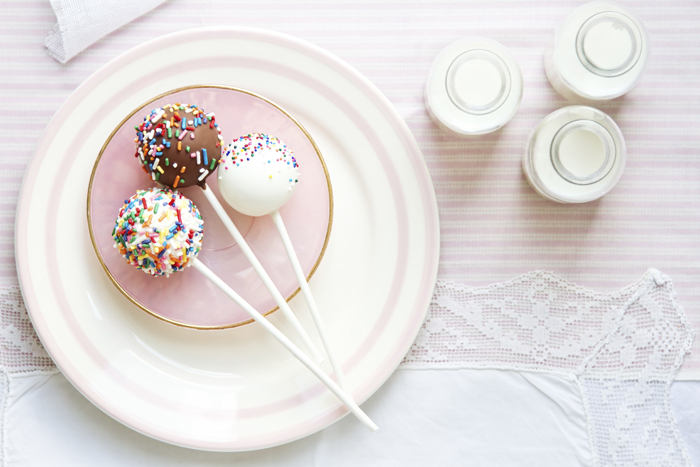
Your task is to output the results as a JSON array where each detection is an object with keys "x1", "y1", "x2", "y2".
[{"x1": 218, "y1": 133, "x2": 299, "y2": 216}]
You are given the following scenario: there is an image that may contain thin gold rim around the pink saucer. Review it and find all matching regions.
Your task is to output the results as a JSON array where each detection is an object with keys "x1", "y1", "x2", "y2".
[{"x1": 87, "y1": 84, "x2": 333, "y2": 330}]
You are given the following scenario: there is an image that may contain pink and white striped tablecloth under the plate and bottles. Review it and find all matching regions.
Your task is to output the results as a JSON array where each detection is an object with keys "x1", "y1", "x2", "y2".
[{"x1": 0, "y1": 0, "x2": 700, "y2": 379}]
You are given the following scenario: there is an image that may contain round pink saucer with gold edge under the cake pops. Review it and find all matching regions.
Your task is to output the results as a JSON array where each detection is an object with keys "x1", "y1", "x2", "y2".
[{"x1": 88, "y1": 86, "x2": 333, "y2": 329}]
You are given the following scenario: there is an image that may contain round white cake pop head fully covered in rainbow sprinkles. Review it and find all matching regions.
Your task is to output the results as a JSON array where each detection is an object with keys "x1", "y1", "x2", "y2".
[{"x1": 112, "y1": 188, "x2": 204, "y2": 277}]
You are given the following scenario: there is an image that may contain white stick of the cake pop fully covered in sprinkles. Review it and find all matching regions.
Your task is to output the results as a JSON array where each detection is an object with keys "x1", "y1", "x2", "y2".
[{"x1": 190, "y1": 258, "x2": 379, "y2": 431}]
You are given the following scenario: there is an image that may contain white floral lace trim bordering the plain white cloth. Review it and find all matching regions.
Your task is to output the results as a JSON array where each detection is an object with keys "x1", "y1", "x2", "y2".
[{"x1": 0, "y1": 270, "x2": 693, "y2": 467}]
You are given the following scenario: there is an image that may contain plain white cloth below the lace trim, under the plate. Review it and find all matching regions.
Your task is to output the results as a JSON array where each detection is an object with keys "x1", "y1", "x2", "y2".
[{"x1": 4, "y1": 370, "x2": 700, "y2": 467}]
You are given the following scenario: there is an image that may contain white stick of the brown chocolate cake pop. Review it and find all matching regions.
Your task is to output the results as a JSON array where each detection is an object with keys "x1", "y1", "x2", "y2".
[{"x1": 202, "y1": 183, "x2": 323, "y2": 363}]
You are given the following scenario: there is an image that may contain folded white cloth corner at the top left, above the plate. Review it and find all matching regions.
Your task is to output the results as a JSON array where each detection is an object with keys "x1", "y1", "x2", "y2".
[{"x1": 44, "y1": 0, "x2": 165, "y2": 63}]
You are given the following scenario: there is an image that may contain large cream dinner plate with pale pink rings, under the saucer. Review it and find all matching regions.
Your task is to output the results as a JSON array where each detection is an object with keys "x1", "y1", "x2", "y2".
[{"x1": 16, "y1": 28, "x2": 439, "y2": 451}]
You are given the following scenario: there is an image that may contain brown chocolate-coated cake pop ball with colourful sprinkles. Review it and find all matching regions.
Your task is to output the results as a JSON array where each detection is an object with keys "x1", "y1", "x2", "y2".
[{"x1": 135, "y1": 104, "x2": 223, "y2": 188}]
